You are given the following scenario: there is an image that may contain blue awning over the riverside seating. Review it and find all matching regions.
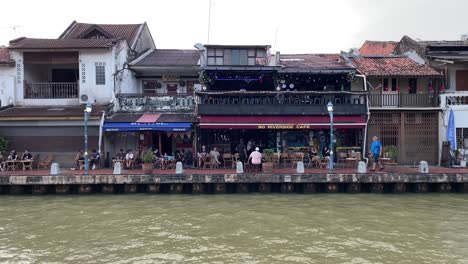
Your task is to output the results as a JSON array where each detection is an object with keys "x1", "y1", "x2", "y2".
[{"x1": 102, "y1": 123, "x2": 192, "y2": 132}]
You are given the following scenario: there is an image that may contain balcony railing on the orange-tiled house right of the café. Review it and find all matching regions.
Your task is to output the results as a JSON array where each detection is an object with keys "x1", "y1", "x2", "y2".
[{"x1": 369, "y1": 94, "x2": 438, "y2": 107}]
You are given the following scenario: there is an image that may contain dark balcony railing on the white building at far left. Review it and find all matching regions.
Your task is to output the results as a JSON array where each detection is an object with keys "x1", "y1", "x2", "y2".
[{"x1": 24, "y1": 82, "x2": 78, "y2": 99}]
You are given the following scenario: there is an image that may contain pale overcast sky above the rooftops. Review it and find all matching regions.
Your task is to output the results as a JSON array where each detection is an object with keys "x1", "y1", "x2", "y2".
[{"x1": 0, "y1": 0, "x2": 468, "y2": 53}]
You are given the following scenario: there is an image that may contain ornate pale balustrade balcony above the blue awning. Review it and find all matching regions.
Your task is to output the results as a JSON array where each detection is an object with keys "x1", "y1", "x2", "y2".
[{"x1": 117, "y1": 94, "x2": 195, "y2": 112}]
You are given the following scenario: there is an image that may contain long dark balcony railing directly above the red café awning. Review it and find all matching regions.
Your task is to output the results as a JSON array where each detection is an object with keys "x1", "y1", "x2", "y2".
[{"x1": 197, "y1": 92, "x2": 366, "y2": 115}]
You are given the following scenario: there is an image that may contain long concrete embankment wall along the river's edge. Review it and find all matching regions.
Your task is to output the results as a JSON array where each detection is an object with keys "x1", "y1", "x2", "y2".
[{"x1": 0, "y1": 174, "x2": 468, "y2": 194}]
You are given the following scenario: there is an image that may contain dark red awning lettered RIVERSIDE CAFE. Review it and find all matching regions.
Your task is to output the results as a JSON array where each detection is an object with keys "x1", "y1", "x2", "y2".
[{"x1": 200, "y1": 116, "x2": 366, "y2": 129}]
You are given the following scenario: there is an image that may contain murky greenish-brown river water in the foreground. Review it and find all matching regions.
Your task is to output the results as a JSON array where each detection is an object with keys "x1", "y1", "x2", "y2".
[{"x1": 0, "y1": 194, "x2": 468, "y2": 264}]
